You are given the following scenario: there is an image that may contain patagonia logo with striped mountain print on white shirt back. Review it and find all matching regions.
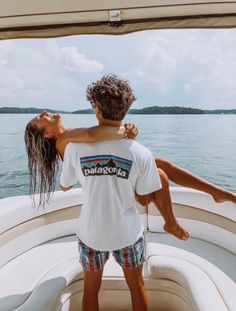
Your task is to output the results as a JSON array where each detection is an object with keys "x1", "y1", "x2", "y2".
[{"x1": 80, "y1": 155, "x2": 133, "y2": 179}]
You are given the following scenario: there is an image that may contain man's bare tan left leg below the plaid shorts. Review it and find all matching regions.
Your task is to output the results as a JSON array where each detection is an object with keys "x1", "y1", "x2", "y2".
[{"x1": 82, "y1": 269, "x2": 103, "y2": 311}]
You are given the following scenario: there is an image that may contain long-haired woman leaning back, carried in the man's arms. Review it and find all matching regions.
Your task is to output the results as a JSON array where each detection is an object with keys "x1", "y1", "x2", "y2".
[{"x1": 25, "y1": 112, "x2": 236, "y2": 240}]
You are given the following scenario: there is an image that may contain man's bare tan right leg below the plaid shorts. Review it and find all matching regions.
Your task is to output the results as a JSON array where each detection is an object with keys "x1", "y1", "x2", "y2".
[{"x1": 123, "y1": 265, "x2": 148, "y2": 311}]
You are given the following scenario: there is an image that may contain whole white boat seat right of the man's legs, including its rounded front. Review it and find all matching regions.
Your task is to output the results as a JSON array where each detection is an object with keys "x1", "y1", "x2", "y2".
[{"x1": 146, "y1": 242, "x2": 236, "y2": 311}]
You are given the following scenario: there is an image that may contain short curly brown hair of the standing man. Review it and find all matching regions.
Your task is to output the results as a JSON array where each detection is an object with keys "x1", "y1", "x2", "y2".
[{"x1": 86, "y1": 75, "x2": 136, "y2": 121}]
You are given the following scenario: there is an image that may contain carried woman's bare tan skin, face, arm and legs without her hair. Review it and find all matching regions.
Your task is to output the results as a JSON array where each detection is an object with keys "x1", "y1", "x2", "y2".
[{"x1": 32, "y1": 112, "x2": 236, "y2": 240}]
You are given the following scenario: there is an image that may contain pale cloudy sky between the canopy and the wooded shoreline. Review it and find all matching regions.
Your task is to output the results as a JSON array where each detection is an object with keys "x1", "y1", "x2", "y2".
[{"x1": 0, "y1": 29, "x2": 236, "y2": 111}]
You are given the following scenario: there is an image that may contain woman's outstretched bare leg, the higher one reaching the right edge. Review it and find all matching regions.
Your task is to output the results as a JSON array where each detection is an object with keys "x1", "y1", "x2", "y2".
[{"x1": 155, "y1": 158, "x2": 236, "y2": 203}]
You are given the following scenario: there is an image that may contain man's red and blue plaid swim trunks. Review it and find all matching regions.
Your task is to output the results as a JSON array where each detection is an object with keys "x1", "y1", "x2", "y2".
[{"x1": 78, "y1": 236, "x2": 145, "y2": 271}]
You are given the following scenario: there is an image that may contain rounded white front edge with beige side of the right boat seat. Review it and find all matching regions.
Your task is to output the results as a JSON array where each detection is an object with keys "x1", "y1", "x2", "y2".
[{"x1": 148, "y1": 255, "x2": 228, "y2": 311}]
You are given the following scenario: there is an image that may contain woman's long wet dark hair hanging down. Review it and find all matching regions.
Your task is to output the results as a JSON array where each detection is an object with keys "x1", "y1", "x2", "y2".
[{"x1": 25, "y1": 122, "x2": 59, "y2": 208}]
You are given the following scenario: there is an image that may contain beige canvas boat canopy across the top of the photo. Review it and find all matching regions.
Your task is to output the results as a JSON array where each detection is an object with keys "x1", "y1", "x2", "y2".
[{"x1": 0, "y1": 0, "x2": 236, "y2": 39}]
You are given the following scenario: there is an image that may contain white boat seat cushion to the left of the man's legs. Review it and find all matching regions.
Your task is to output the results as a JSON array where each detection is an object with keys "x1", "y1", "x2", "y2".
[{"x1": 0, "y1": 236, "x2": 83, "y2": 311}]
